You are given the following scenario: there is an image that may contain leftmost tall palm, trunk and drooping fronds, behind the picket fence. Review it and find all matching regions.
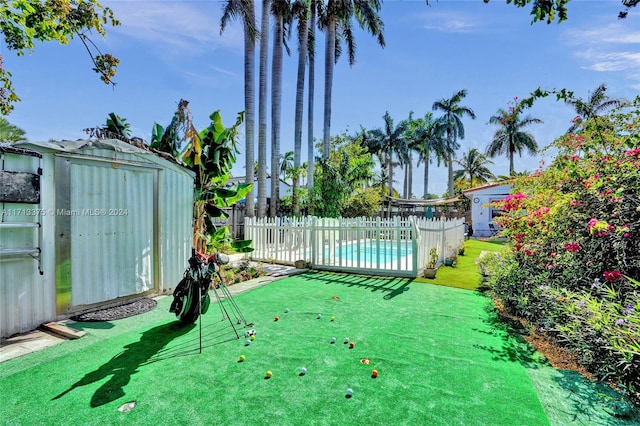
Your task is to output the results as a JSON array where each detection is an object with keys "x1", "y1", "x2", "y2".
[{"x1": 220, "y1": 0, "x2": 258, "y2": 217}]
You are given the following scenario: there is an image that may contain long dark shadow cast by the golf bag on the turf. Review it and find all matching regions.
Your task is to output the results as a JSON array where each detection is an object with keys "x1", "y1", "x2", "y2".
[{"x1": 52, "y1": 321, "x2": 237, "y2": 407}]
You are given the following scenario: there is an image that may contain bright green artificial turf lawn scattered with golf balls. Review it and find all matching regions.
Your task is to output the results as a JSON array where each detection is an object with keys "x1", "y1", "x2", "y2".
[{"x1": 0, "y1": 272, "x2": 549, "y2": 425}]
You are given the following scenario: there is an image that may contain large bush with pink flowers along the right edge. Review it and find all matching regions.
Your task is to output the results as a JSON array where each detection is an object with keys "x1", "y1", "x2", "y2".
[{"x1": 487, "y1": 98, "x2": 640, "y2": 401}]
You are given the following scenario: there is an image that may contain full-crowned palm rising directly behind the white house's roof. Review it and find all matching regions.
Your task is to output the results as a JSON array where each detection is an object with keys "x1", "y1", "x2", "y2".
[{"x1": 486, "y1": 108, "x2": 542, "y2": 175}]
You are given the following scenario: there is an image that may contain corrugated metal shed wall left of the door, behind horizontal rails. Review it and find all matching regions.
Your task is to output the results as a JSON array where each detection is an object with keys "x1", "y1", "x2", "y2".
[{"x1": 0, "y1": 153, "x2": 55, "y2": 337}]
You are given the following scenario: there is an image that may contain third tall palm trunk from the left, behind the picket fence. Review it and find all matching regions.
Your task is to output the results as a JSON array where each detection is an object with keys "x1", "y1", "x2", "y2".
[{"x1": 269, "y1": 15, "x2": 284, "y2": 217}]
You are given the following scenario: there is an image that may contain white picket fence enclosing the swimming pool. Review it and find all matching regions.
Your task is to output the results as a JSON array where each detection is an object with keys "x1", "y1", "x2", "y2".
[{"x1": 245, "y1": 216, "x2": 464, "y2": 277}]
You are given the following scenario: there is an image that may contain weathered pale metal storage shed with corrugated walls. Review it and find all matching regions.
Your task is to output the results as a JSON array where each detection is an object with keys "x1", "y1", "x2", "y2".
[{"x1": 0, "y1": 140, "x2": 194, "y2": 337}]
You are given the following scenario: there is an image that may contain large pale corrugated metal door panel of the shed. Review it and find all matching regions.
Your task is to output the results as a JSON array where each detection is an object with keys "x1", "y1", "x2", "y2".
[{"x1": 70, "y1": 159, "x2": 158, "y2": 306}]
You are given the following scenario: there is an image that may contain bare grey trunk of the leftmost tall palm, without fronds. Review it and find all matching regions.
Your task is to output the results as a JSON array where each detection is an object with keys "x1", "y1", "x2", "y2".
[{"x1": 244, "y1": 6, "x2": 256, "y2": 217}]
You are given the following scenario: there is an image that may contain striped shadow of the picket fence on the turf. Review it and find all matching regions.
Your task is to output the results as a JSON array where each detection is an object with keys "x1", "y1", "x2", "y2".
[{"x1": 301, "y1": 272, "x2": 413, "y2": 300}]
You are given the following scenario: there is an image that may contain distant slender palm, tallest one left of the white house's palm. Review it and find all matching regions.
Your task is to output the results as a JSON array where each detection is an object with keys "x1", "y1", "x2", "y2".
[{"x1": 432, "y1": 89, "x2": 476, "y2": 198}]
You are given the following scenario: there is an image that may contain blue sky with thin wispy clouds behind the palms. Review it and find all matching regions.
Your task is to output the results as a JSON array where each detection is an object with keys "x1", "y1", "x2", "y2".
[{"x1": 5, "y1": 0, "x2": 640, "y2": 198}]
